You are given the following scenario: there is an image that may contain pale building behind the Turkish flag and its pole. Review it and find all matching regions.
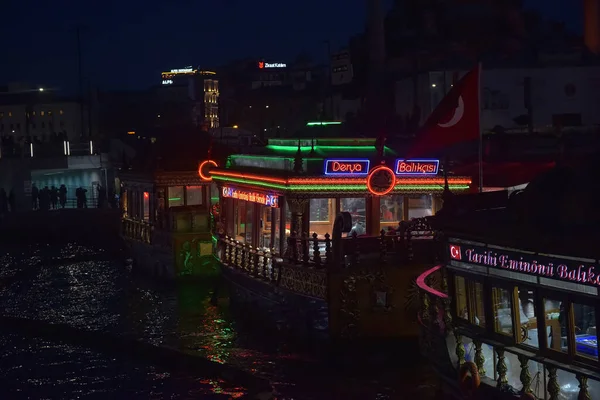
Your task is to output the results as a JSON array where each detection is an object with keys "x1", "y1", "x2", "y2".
[{"x1": 396, "y1": 66, "x2": 600, "y2": 131}]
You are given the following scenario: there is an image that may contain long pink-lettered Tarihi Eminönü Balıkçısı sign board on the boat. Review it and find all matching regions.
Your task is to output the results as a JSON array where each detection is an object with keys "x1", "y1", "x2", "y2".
[{"x1": 448, "y1": 243, "x2": 600, "y2": 287}]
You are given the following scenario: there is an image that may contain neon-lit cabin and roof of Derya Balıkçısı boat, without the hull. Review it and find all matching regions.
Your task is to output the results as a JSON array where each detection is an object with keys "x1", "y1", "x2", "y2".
[{"x1": 210, "y1": 139, "x2": 471, "y2": 254}]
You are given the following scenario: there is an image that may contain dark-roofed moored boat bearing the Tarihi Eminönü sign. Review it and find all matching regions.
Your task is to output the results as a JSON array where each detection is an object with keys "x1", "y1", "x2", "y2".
[{"x1": 418, "y1": 160, "x2": 600, "y2": 400}]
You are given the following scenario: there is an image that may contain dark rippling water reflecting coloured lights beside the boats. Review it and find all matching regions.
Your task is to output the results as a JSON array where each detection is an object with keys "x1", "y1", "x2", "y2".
[{"x1": 0, "y1": 244, "x2": 433, "y2": 400}]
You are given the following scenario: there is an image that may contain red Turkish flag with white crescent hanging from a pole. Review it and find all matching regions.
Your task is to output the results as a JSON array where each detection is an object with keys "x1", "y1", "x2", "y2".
[{"x1": 406, "y1": 65, "x2": 481, "y2": 159}]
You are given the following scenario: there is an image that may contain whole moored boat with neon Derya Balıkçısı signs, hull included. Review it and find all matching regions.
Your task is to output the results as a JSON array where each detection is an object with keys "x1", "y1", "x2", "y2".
[{"x1": 210, "y1": 139, "x2": 471, "y2": 340}]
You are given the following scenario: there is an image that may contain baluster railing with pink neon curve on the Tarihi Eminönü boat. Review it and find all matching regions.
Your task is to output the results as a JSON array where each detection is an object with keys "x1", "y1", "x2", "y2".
[{"x1": 417, "y1": 266, "x2": 600, "y2": 400}]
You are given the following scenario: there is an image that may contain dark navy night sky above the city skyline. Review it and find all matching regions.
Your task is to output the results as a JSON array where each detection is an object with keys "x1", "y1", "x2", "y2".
[{"x1": 0, "y1": 0, "x2": 581, "y2": 91}]
